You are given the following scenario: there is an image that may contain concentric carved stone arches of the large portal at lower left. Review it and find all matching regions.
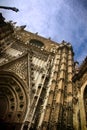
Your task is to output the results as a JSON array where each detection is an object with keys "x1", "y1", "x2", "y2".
[{"x1": 0, "y1": 71, "x2": 29, "y2": 122}]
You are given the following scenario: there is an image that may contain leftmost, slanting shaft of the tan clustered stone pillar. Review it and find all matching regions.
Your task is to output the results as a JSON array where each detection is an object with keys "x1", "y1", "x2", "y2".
[{"x1": 42, "y1": 56, "x2": 58, "y2": 130}]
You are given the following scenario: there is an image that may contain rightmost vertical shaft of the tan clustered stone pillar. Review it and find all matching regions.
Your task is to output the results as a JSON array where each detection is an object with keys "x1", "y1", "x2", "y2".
[{"x1": 67, "y1": 50, "x2": 73, "y2": 130}]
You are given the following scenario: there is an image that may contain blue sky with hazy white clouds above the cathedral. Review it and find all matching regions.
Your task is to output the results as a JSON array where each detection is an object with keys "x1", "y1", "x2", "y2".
[{"x1": 0, "y1": 0, "x2": 87, "y2": 64}]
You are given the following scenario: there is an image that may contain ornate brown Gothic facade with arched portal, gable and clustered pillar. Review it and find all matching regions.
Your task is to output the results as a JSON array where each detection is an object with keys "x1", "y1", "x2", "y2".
[{"x1": 0, "y1": 12, "x2": 86, "y2": 130}]
